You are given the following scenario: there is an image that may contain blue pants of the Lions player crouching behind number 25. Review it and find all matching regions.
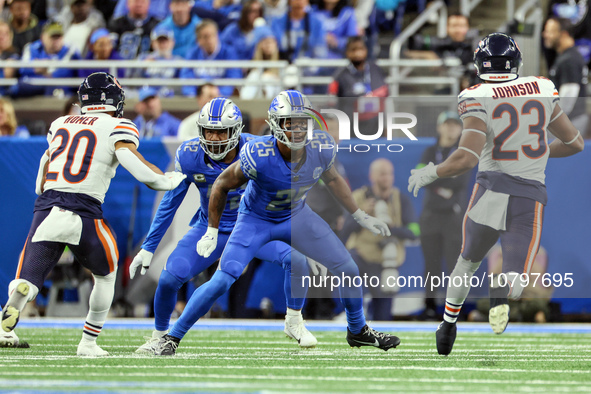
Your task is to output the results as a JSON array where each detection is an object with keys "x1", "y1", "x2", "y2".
[{"x1": 154, "y1": 226, "x2": 307, "y2": 331}]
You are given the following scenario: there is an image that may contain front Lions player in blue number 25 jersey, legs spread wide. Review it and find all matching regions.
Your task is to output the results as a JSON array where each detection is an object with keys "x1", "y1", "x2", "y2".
[{"x1": 156, "y1": 90, "x2": 400, "y2": 355}]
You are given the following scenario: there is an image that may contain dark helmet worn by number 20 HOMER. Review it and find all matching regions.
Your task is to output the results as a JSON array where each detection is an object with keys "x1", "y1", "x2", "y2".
[{"x1": 78, "y1": 72, "x2": 125, "y2": 118}]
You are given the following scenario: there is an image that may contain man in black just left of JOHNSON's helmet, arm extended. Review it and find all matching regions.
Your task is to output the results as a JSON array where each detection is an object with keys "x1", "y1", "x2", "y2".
[{"x1": 405, "y1": 14, "x2": 477, "y2": 89}]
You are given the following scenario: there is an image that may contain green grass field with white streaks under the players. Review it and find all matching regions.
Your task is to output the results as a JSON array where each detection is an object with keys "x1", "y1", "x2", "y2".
[{"x1": 0, "y1": 326, "x2": 591, "y2": 393}]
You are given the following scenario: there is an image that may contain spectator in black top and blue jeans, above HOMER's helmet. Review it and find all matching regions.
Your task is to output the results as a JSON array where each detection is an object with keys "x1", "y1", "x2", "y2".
[{"x1": 109, "y1": 0, "x2": 159, "y2": 59}]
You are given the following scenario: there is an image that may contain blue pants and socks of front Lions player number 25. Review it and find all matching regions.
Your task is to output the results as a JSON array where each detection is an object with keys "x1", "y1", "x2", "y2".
[{"x1": 170, "y1": 205, "x2": 365, "y2": 338}]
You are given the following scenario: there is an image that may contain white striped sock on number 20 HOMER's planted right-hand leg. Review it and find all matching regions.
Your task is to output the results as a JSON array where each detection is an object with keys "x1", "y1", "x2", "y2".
[{"x1": 82, "y1": 270, "x2": 117, "y2": 342}]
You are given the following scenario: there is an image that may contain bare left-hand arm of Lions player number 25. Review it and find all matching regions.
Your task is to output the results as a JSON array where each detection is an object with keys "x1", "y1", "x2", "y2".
[{"x1": 208, "y1": 162, "x2": 248, "y2": 228}]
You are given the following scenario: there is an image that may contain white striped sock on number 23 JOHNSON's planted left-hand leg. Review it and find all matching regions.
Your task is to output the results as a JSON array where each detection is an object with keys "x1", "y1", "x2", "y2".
[{"x1": 443, "y1": 255, "x2": 480, "y2": 323}]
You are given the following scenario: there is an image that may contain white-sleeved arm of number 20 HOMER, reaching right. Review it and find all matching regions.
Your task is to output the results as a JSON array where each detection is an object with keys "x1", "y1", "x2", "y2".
[{"x1": 115, "y1": 141, "x2": 187, "y2": 190}]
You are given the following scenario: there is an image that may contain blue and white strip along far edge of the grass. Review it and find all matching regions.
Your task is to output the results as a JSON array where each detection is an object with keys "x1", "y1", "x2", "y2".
[{"x1": 19, "y1": 318, "x2": 591, "y2": 335}]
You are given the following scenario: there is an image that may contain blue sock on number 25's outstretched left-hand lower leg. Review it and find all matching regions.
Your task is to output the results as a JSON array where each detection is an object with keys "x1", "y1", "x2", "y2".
[{"x1": 169, "y1": 270, "x2": 236, "y2": 339}]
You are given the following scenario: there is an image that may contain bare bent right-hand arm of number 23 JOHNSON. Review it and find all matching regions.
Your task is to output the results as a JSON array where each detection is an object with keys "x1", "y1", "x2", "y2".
[{"x1": 548, "y1": 105, "x2": 585, "y2": 157}]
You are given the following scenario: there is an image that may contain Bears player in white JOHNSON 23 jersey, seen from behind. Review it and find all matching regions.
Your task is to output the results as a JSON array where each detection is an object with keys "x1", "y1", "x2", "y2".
[{"x1": 408, "y1": 33, "x2": 584, "y2": 355}]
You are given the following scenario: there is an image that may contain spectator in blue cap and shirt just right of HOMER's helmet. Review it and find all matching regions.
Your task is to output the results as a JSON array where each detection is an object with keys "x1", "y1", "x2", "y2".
[{"x1": 133, "y1": 87, "x2": 181, "y2": 138}]
